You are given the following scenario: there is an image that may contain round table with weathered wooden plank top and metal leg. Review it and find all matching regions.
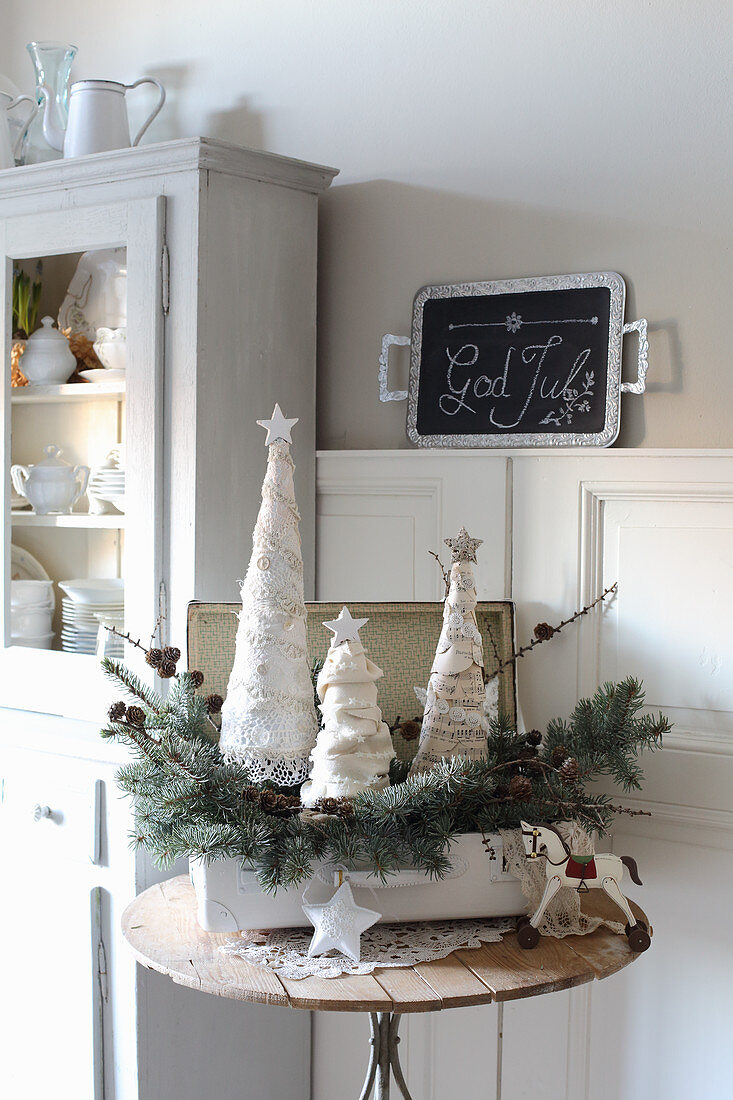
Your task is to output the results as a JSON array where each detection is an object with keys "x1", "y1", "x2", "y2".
[{"x1": 122, "y1": 876, "x2": 652, "y2": 1100}]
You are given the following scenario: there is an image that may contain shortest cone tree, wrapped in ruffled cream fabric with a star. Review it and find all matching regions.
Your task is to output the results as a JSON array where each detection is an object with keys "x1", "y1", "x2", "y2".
[{"x1": 300, "y1": 607, "x2": 394, "y2": 806}]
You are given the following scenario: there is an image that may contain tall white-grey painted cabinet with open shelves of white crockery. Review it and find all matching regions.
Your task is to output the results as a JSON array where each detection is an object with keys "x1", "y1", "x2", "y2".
[{"x1": 0, "y1": 139, "x2": 335, "y2": 1100}]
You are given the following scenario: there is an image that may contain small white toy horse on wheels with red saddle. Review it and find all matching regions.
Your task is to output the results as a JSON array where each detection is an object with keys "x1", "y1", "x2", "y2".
[{"x1": 517, "y1": 822, "x2": 652, "y2": 952}]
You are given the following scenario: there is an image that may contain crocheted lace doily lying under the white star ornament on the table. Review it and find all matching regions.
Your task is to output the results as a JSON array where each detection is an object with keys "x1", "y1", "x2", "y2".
[{"x1": 219, "y1": 916, "x2": 515, "y2": 979}]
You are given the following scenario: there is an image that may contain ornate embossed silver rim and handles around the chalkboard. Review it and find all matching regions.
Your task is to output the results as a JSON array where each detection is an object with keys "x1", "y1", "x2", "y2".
[{"x1": 379, "y1": 272, "x2": 648, "y2": 448}]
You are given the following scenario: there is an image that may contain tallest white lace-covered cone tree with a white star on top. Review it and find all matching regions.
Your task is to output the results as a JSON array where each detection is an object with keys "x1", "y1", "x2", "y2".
[{"x1": 219, "y1": 405, "x2": 318, "y2": 785}]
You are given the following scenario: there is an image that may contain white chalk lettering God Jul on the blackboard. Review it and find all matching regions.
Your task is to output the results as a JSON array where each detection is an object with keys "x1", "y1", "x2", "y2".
[{"x1": 438, "y1": 334, "x2": 593, "y2": 429}]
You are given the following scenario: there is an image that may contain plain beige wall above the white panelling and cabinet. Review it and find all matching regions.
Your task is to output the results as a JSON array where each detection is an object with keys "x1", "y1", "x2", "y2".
[{"x1": 0, "y1": 0, "x2": 733, "y2": 448}]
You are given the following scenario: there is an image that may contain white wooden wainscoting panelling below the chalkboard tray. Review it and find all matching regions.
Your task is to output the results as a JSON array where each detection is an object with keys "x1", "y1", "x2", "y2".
[{"x1": 313, "y1": 450, "x2": 733, "y2": 1100}]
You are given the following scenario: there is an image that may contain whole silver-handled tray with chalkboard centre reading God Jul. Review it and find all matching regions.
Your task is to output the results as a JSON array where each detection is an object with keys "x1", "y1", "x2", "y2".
[{"x1": 380, "y1": 272, "x2": 647, "y2": 447}]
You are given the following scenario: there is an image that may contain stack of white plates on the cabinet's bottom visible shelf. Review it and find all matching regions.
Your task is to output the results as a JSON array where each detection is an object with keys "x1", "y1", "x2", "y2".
[{"x1": 58, "y1": 578, "x2": 124, "y2": 657}]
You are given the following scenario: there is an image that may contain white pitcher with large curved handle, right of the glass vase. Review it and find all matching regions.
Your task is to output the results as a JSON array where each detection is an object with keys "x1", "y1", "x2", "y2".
[{"x1": 39, "y1": 76, "x2": 165, "y2": 157}]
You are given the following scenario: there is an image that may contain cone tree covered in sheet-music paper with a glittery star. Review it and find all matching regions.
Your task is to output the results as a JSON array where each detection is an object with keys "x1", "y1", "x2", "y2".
[{"x1": 411, "y1": 527, "x2": 486, "y2": 776}]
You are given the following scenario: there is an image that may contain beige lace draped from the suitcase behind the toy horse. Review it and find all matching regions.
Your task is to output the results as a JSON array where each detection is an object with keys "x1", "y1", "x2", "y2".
[{"x1": 500, "y1": 822, "x2": 625, "y2": 939}]
